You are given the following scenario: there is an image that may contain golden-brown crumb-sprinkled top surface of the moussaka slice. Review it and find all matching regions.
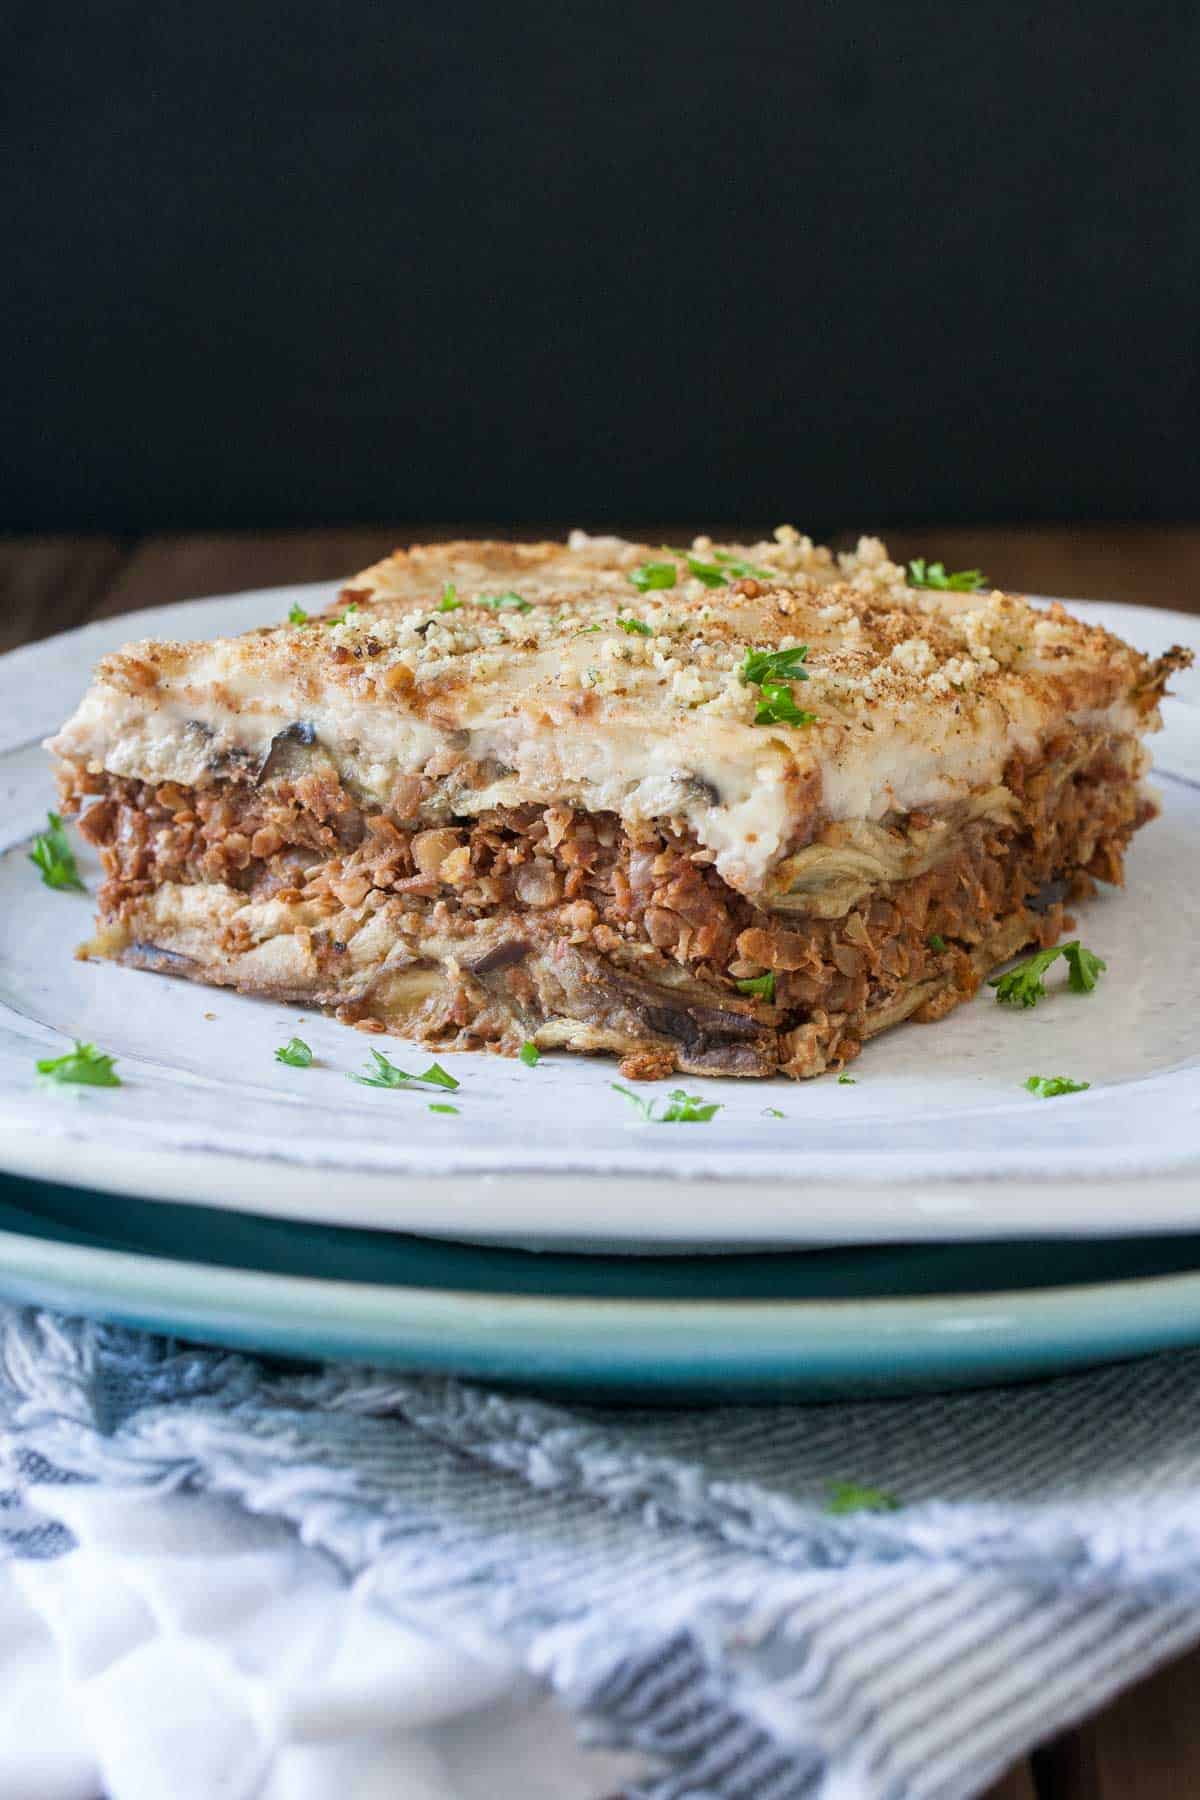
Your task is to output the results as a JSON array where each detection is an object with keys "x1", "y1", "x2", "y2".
[{"x1": 97, "y1": 540, "x2": 1165, "y2": 731}]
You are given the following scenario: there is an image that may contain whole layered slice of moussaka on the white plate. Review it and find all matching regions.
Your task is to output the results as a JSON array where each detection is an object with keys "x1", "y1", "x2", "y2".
[{"x1": 50, "y1": 527, "x2": 1186, "y2": 1076}]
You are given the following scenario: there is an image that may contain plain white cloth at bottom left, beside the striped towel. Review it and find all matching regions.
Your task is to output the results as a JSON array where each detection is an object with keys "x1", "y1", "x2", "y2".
[{"x1": 0, "y1": 1483, "x2": 639, "y2": 1800}]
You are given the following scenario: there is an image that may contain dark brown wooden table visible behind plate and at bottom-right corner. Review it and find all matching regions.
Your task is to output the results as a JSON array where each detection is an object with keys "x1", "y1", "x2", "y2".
[{"x1": 0, "y1": 524, "x2": 1200, "y2": 1800}]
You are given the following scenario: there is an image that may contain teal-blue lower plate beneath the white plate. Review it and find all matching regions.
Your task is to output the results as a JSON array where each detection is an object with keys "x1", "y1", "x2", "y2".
[{"x1": 0, "y1": 1177, "x2": 1200, "y2": 1400}]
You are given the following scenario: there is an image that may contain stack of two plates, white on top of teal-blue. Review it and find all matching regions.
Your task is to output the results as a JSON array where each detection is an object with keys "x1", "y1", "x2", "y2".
[{"x1": 0, "y1": 589, "x2": 1200, "y2": 1399}]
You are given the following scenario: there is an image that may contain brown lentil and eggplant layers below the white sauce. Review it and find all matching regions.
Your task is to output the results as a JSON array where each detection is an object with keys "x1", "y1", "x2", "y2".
[{"x1": 63, "y1": 731, "x2": 1153, "y2": 1076}]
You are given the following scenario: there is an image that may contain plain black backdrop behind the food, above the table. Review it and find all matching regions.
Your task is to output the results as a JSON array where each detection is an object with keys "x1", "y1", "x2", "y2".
[{"x1": 0, "y1": 0, "x2": 1200, "y2": 531}]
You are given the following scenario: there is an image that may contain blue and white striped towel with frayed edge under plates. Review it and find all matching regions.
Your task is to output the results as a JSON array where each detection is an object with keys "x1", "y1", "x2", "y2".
[{"x1": 0, "y1": 1312, "x2": 1200, "y2": 1800}]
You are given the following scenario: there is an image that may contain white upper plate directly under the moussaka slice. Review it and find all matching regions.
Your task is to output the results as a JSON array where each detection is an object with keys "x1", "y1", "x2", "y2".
[{"x1": 0, "y1": 587, "x2": 1200, "y2": 1247}]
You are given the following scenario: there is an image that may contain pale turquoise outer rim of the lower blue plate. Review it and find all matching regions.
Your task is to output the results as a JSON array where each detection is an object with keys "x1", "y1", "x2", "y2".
[{"x1": 11, "y1": 1229, "x2": 1200, "y2": 1393}]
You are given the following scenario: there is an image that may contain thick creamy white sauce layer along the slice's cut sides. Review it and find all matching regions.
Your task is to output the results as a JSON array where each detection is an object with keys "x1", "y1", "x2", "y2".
[{"x1": 49, "y1": 671, "x2": 1135, "y2": 895}]
